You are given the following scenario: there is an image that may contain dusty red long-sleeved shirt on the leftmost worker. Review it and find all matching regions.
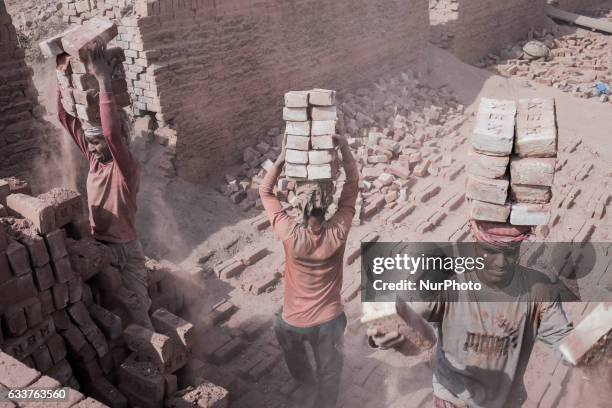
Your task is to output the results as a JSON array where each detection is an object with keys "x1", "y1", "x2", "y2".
[{"x1": 57, "y1": 89, "x2": 140, "y2": 243}]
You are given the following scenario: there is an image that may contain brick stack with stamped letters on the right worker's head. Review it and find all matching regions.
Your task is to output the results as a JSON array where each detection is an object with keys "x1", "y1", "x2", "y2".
[{"x1": 466, "y1": 98, "x2": 557, "y2": 226}]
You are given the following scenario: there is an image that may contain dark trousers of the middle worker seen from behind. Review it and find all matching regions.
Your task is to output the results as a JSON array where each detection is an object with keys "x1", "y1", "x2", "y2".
[{"x1": 274, "y1": 313, "x2": 346, "y2": 408}]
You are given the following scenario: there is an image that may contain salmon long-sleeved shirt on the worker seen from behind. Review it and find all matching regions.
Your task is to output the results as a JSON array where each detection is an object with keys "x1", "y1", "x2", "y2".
[{"x1": 259, "y1": 166, "x2": 359, "y2": 328}]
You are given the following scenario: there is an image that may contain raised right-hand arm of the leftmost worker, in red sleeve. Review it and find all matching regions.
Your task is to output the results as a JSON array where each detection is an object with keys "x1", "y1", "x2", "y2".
[{"x1": 87, "y1": 44, "x2": 135, "y2": 177}]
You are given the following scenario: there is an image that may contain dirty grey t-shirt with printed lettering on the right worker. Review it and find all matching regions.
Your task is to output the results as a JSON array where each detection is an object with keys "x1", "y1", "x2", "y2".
[{"x1": 408, "y1": 267, "x2": 573, "y2": 408}]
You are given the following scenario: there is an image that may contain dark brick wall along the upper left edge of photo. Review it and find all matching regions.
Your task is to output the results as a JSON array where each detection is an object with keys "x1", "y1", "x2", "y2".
[{"x1": 0, "y1": 0, "x2": 43, "y2": 177}]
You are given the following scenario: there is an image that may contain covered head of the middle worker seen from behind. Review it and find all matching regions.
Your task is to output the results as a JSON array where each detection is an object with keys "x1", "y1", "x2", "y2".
[{"x1": 295, "y1": 181, "x2": 334, "y2": 229}]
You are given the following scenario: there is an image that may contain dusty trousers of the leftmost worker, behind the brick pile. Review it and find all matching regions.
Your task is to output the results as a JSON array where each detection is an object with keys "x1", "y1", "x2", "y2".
[{"x1": 105, "y1": 239, "x2": 153, "y2": 329}]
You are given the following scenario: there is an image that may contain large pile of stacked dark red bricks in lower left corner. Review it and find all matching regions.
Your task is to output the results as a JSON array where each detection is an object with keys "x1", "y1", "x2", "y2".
[{"x1": 0, "y1": 178, "x2": 228, "y2": 408}]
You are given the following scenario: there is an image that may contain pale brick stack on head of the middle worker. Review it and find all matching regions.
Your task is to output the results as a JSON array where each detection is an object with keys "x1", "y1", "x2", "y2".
[{"x1": 283, "y1": 89, "x2": 338, "y2": 180}]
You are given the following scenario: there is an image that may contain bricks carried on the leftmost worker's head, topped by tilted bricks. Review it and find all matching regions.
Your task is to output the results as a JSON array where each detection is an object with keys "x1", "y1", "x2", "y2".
[{"x1": 40, "y1": 17, "x2": 130, "y2": 129}]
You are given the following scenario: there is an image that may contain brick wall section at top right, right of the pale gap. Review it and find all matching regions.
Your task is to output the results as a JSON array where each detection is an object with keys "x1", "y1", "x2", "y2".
[{"x1": 454, "y1": 0, "x2": 546, "y2": 62}]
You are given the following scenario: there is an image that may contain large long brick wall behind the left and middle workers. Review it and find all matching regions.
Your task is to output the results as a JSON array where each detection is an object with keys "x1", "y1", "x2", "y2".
[{"x1": 126, "y1": 0, "x2": 428, "y2": 181}]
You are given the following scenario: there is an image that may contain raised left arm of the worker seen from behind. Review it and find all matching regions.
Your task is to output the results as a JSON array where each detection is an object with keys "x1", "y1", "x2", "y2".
[{"x1": 259, "y1": 137, "x2": 296, "y2": 241}]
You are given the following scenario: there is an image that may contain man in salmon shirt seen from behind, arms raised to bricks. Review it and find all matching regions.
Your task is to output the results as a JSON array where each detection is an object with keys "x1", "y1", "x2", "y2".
[{"x1": 259, "y1": 136, "x2": 359, "y2": 408}]
